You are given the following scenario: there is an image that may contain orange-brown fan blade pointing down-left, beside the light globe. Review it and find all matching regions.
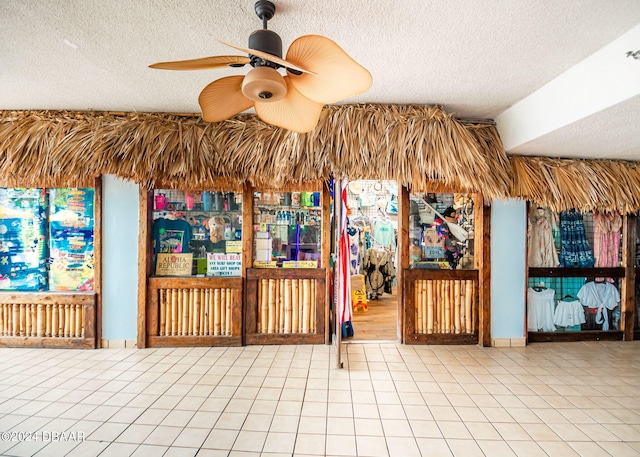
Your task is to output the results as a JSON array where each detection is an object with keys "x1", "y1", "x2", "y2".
[{"x1": 198, "y1": 76, "x2": 253, "y2": 122}]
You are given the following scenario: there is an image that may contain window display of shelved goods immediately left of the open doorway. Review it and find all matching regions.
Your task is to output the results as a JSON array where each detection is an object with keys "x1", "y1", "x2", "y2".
[{"x1": 253, "y1": 192, "x2": 322, "y2": 268}]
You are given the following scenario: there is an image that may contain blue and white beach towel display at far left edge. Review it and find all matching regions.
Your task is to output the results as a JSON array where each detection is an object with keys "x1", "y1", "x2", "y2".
[{"x1": 0, "y1": 188, "x2": 47, "y2": 290}]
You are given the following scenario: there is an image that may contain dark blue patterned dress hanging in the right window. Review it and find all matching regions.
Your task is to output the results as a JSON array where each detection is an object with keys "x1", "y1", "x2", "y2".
[{"x1": 560, "y1": 209, "x2": 595, "y2": 268}]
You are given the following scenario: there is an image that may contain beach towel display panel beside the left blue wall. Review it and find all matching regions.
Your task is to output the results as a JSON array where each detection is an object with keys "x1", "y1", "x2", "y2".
[{"x1": 48, "y1": 188, "x2": 94, "y2": 291}]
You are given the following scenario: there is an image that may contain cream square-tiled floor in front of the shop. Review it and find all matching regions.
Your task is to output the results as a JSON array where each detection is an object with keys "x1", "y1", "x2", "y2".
[{"x1": 0, "y1": 342, "x2": 640, "y2": 457}]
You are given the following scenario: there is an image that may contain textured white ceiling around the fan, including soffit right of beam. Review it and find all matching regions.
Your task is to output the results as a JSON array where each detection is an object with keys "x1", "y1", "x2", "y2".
[{"x1": 0, "y1": 0, "x2": 640, "y2": 160}]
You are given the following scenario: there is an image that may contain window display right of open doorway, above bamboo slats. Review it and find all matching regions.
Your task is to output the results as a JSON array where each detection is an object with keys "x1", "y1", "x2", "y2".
[{"x1": 409, "y1": 193, "x2": 474, "y2": 270}]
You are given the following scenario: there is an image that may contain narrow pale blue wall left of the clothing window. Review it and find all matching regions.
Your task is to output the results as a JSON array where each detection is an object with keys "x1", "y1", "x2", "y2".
[{"x1": 491, "y1": 199, "x2": 527, "y2": 338}]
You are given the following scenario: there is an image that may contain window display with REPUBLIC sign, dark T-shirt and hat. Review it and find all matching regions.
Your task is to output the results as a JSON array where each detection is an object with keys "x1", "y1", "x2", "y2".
[{"x1": 152, "y1": 189, "x2": 242, "y2": 277}]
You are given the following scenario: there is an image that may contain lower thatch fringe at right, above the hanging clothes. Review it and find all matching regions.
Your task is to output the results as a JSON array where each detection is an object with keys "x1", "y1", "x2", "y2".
[{"x1": 509, "y1": 156, "x2": 640, "y2": 214}]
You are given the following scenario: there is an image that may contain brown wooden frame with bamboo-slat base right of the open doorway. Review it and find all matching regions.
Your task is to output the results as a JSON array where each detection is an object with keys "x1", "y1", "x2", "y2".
[{"x1": 398, "y1": 191, "x2": 491, "y2": 346}]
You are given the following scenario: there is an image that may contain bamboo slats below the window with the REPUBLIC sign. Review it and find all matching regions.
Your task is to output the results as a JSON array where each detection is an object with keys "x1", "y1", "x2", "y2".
[{"x1": 157, "y1": 288, "x2": 235, "y2": 336}]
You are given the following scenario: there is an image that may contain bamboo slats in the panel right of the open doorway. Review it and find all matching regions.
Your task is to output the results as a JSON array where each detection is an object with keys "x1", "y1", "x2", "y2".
[{"x1": 414, "y1": 279, "x2": 478, "y2": 334}]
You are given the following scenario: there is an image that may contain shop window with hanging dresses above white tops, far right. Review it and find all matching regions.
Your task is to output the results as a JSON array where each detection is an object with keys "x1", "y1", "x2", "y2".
[{"x1": 527, "y1": 207, "x2": 624, "y2": 332}]
